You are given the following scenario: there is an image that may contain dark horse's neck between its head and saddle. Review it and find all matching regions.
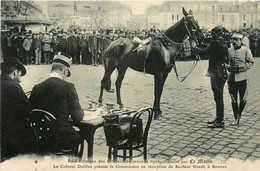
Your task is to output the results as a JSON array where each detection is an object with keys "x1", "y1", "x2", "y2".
[{"x1": 165, "y1": 17, "x2": 186, "y2": 43}]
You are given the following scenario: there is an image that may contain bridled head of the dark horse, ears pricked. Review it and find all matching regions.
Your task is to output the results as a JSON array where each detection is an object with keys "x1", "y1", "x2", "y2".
[{"x1": 182, "y1": 7, "x2": 204, "y2": 43}]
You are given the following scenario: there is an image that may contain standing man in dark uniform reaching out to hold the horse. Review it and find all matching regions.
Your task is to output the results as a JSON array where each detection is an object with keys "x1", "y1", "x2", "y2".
[{"x1": 192, "y1": 26, "x2": 228, "y2": 128}]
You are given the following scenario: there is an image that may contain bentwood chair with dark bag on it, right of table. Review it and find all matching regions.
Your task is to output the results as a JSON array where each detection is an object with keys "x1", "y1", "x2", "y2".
[{"x1": 104, "y1": 108, "x2": 153, "y2": 161}]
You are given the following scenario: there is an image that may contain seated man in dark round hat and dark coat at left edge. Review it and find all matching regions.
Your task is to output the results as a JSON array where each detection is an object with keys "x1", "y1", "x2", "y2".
[{"x1": 1, "y1": 57, "x2": 36, "y2": 161}]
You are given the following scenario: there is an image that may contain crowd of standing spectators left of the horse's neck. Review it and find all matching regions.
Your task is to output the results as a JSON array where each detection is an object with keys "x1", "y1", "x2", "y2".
[{"x1": 1, "y1": 29, "x2": 165, "y2": 66}]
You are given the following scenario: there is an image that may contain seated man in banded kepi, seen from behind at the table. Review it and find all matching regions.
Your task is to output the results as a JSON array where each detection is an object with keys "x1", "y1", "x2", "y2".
[{"x1": 29, "y1": 52, "x2": 84, "y2": 150}]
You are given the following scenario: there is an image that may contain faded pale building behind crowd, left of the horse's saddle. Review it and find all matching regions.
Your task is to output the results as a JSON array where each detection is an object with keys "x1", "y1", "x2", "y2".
[{"x1": 48, "y1": 1, "x2": 132, "y2": 30}]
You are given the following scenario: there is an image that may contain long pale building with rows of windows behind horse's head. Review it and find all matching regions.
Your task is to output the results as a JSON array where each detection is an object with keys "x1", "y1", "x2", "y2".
[{"x1": 146, "y1": 1, "x2": 260, "y2": 30}]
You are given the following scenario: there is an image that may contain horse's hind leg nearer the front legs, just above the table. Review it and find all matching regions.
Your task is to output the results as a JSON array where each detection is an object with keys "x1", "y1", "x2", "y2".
[{"x1": 116, "y1": 67, "x2": 127, "y2": 108}]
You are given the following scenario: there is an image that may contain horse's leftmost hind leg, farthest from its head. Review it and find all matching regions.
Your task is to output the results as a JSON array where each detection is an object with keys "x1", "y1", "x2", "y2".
[{"x1": 98, "y1": 67, "x2": 115, "y2": 106}]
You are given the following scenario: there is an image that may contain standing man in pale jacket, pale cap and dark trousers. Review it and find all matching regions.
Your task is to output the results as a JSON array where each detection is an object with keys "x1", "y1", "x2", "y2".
[{"x1": 227, "y1": 34, "x2": 254, "y2": 126}]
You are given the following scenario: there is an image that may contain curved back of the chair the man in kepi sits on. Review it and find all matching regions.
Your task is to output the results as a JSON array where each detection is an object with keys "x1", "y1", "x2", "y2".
[{"x1": 29, "y1": 109, "x2": 58, "y2": 154}]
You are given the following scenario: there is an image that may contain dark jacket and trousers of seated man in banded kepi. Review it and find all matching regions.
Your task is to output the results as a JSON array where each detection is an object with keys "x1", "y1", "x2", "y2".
[{"x1": 29, "y1": 77, "x2": 84, "y2": 149}]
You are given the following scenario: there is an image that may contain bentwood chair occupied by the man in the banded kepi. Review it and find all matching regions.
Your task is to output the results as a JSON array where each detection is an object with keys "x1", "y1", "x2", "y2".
[{"x1": 29, "y1": 109, "x2": 84, "y2": 158}]
